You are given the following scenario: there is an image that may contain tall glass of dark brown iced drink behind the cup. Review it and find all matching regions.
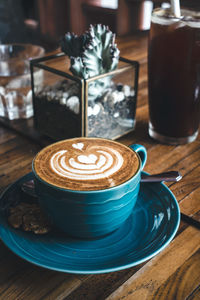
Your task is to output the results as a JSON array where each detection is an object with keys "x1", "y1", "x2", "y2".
[{"x1": 148, "y1": 9, "x2": 200, "y2": 144}]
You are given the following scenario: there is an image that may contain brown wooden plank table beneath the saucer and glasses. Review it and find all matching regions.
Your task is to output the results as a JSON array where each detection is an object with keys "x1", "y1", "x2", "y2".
[{"x1": 0, "y1": 36, "x2": 200, "y2": 300}]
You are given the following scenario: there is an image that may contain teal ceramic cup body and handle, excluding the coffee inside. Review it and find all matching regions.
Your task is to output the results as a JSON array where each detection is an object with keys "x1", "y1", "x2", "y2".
[{"x1": 33, "y1": 144, "x2": 147, "y2": 238}]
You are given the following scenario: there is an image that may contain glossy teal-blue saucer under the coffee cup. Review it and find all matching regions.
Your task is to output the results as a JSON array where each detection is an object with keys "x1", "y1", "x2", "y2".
[{"x1": 0, "y1": 173, "x2": 180, "y2": 274}]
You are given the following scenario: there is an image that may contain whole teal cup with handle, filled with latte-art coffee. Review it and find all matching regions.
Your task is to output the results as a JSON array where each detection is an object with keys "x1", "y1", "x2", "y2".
[{"x1": 33, "y1": 137, "x2": 147, "y2": 238}]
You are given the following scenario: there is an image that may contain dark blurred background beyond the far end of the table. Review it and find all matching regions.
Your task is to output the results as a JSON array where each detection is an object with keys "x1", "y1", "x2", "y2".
[{"x1": 0, "y1": 0, "x2": 200, "y2": 51}]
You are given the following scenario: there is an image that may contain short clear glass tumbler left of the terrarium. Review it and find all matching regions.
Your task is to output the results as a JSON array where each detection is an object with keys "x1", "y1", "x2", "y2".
[{"x1": 0, "y1": 44, "x2": 44, "y2": 120}]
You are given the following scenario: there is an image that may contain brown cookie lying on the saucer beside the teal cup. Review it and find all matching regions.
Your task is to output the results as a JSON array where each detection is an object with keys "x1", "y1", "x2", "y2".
[{"x1": 8, "y1": 202, "x2": 51, "y2": 234}]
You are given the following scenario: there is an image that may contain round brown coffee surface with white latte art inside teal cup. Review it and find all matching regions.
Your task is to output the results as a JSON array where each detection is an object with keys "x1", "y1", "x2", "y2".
[{"x1": 34, "y1": 138, "x2": 139, "y2": 190}]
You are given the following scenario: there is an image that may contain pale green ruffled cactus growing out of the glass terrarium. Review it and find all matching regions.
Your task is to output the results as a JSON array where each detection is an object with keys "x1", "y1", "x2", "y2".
[{"x1": 61, "y1": 24, "x2": 119, "y2": 101}]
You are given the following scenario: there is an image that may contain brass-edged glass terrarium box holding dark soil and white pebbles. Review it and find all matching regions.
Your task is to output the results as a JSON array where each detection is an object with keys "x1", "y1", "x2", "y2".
[{"x1": 31, "y1": 53, "x2": 139, "y2": 140}]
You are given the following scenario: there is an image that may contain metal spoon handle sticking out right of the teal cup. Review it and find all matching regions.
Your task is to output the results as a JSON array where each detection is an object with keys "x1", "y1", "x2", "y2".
[{"x1": 141, "y1": 171, "x2": 182, "y2": 182}]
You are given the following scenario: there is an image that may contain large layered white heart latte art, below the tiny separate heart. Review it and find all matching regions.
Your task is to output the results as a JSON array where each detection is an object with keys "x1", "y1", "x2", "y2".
[{"x1": 50, "y1": 147, "x2": 123, "y2": 180}]
